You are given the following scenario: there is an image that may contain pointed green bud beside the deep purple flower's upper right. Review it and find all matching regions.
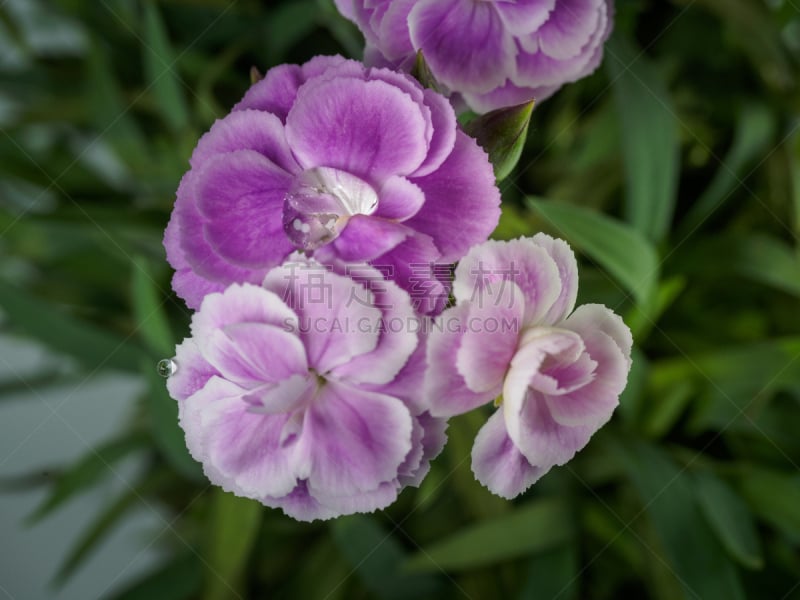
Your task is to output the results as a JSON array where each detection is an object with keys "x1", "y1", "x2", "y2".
[{"x1": 460, "y1": 101, "x2": 534, "y2": 181}]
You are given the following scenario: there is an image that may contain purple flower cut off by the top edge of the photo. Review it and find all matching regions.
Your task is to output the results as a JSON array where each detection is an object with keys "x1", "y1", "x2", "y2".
[{"x1": 336, "y1": 0, "x2": 613, "y2": 113}]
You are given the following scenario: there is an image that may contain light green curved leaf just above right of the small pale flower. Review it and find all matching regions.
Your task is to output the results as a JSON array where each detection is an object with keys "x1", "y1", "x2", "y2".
[{"x1": 528, "y1": 198, "x2": 660, "y2": 307}]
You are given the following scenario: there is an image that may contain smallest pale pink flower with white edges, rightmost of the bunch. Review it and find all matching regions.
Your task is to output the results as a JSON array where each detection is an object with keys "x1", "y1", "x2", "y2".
[{"x1": 425, "y1": 234, "x2": 632, "y2": 498}]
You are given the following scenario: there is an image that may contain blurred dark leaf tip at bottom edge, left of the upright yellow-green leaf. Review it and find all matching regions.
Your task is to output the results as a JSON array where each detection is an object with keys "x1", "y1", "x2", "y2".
[{"x1": 111, "y1": 553, "x2": 203, "y2": 600}]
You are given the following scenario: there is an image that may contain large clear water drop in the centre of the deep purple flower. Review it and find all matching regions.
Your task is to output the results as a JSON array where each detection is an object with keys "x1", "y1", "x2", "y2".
[{"x1": 283, "y1": 167, "x2": 378, "y2": 250}]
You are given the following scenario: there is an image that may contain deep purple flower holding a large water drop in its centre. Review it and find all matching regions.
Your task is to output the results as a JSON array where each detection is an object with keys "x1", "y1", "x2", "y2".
[{"x1": 164, "y1": 57, "x2": 500, "y2": 313}]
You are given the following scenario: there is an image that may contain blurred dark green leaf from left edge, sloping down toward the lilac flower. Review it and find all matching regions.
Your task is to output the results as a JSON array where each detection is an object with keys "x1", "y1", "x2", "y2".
[{"x1": 0, "y1": 281, "x2": 142, "y2": 371}]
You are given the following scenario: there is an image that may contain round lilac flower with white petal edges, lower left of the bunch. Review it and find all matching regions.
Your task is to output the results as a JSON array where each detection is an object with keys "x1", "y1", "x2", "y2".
[{"x1": 168, "y1": 256, "x2": 445, "y2": 520}]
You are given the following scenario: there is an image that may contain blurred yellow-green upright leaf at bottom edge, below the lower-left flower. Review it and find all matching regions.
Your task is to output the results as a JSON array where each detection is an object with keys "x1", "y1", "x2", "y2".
[{"x1": 203, "y1": 488, "x2": 264, "y2": 600}]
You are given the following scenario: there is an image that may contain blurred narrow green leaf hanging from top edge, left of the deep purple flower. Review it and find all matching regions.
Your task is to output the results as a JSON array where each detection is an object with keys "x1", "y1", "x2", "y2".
[{"x1": 142, "y1": 0, "x2": 189, "y2": 132}]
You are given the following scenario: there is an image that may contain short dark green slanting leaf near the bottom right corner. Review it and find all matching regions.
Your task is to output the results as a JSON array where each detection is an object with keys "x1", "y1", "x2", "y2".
[{"x1": 693, "y1": 471, "x2": 764, "y2": 569}]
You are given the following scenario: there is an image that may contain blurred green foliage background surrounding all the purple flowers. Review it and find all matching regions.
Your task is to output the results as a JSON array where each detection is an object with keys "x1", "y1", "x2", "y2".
[{"x1": 0, "y1": 0, "x2": 800, "y2": 600}]
